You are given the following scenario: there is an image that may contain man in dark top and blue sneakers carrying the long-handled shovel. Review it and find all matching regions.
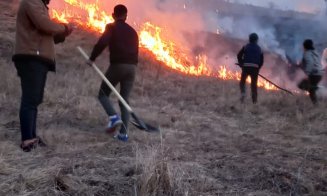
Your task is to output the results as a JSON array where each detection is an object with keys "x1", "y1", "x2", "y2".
[{"x1": 88, "y1": 5, "x2": 139, "y2": 142}]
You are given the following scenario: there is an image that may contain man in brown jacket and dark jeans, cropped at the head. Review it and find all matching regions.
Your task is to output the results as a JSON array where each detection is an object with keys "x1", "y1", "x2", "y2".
[{"x1": 13, "y1": 0, "x2": 73, "y2": 152}]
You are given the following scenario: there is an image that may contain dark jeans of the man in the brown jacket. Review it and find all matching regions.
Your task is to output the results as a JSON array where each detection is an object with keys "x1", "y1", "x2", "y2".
[{"x1": 15, "y1": 60, "x2": 49, "y2": 141}]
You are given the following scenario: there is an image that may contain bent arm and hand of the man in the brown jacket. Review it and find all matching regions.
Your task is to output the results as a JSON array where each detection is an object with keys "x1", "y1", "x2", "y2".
[{"x1": 23, "y1": 0, "x2": 69, "y2": 35}]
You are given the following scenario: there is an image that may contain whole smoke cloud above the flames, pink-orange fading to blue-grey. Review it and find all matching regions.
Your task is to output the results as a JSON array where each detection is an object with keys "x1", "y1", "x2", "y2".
[{"x1": 51, "y1": 0, "x2": 327, "y2": 89}]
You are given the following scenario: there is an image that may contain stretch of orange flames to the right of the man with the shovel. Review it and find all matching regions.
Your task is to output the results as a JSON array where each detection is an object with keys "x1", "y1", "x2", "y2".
[{"x1": 140, "y1": 22, "x2": 277, "y2": 90}]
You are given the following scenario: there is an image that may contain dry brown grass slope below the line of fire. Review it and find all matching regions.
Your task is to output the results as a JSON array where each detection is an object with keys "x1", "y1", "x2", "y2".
[{"x1": 0, "y1": 1, "x2": 327, "y2": 196}]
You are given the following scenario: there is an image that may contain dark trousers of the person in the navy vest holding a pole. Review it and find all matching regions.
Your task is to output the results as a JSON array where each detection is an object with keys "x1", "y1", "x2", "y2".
[{"x1": 240, "y1": 67, "x2": 259, "y2": 103}]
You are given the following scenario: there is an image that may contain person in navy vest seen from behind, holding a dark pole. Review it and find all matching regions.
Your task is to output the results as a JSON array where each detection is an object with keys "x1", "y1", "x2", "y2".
[{"x1": 237, "y1": 33, "x2": 264, "y2": 104}]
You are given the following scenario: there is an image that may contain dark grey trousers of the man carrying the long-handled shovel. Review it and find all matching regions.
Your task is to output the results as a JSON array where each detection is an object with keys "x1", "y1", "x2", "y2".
[{"x1": 98, "y1": 64, "x2": 136, "y2": 134}]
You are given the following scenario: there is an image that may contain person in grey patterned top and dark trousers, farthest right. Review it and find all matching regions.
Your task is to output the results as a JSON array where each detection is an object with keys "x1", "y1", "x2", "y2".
[{"x1": 298, "y1": 39, "x2": 324, "y2": 104}]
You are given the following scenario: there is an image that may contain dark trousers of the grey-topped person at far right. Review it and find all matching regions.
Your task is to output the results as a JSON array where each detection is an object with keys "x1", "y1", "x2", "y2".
[{"x1": 298, "y1": 75, "x2": 322, "y2": 104}]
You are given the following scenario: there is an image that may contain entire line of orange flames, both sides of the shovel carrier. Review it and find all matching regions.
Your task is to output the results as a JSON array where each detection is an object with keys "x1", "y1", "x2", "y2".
[{"x1": 51, "y1": 0, "x2": 277, "y2": 90}]
